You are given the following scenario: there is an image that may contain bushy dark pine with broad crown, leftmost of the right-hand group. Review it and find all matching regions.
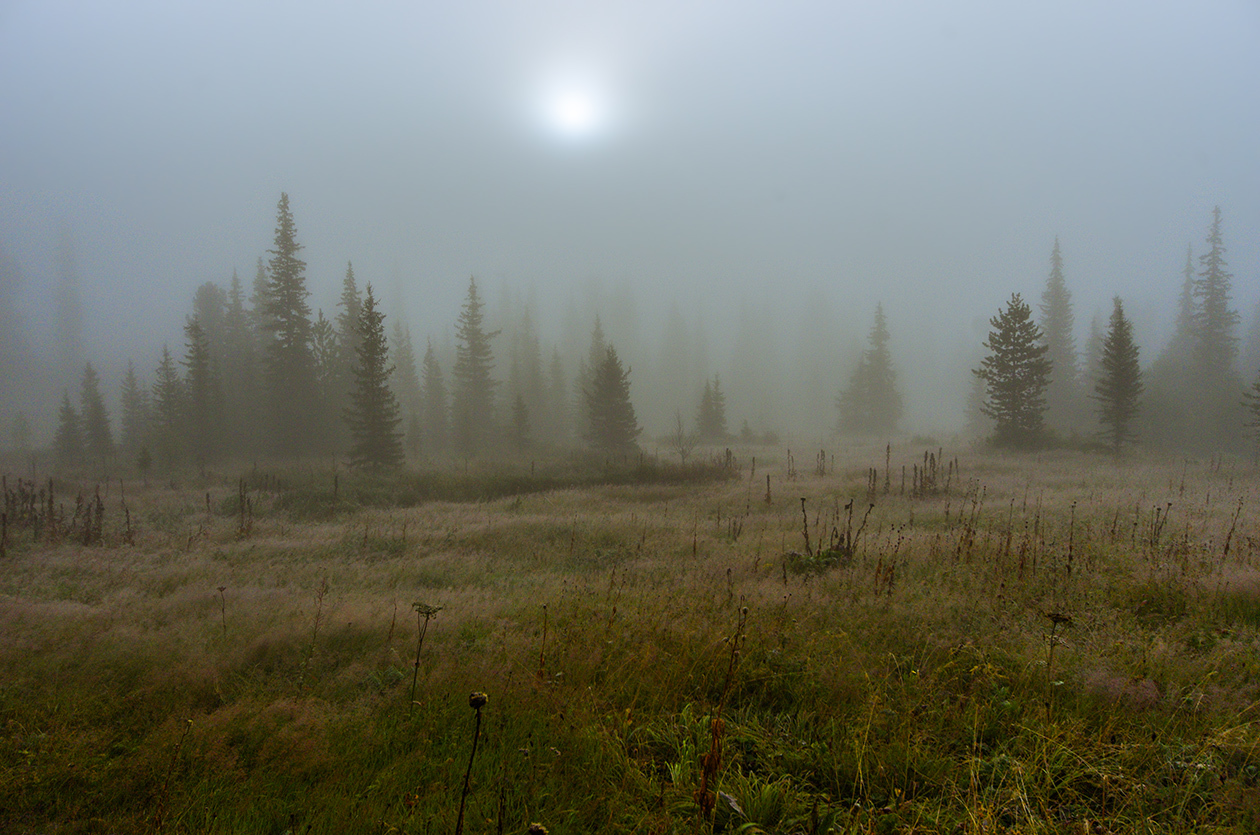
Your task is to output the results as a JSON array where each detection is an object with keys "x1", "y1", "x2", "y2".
[{"x1": 973, "y1": 293, "x2": 1053, "y2": 447}]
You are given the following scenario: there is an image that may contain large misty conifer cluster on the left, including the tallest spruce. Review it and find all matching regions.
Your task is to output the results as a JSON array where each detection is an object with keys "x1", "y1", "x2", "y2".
[{"x1": 35, "y1": 194, "x2": 641, "y2": 471}]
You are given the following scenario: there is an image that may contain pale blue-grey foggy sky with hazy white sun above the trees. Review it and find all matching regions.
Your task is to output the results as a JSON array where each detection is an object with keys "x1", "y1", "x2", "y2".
[{"x1": 0, "y1": 0, "x2": 1260, "y2": 443}]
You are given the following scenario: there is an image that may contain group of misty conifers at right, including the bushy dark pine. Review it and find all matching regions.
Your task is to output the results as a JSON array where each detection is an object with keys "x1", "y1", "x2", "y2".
[{"x1": 974, "y1": 207, "x2": 1260, "y2": 453}]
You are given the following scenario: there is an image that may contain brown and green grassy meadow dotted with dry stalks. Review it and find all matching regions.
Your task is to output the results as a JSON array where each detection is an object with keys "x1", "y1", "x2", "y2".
[{"x1": 0, "y1": 445, "x2": 1260, "y2": 835}]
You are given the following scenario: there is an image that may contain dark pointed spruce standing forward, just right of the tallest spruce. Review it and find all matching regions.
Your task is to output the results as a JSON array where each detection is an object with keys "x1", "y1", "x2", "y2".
[{"x1": 345, "y1": 283, "x2": 403, "y2": 469}]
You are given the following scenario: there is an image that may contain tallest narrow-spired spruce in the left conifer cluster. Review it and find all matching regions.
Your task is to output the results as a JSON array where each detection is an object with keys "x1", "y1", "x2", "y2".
[{"x1": 262, "y1": 194, "x2": 320, "y2": 457}]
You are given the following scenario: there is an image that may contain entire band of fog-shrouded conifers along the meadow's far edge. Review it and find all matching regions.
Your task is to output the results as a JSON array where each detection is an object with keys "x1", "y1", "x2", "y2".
[{"x1": 0, "y1": 195, "x2": 1260, "y2": 471}]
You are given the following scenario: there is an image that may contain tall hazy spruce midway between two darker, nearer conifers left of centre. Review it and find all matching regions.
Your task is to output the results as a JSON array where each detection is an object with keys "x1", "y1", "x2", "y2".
[{"x1": 451, "y1": 278, "x2": 499, "y2": 455}]
